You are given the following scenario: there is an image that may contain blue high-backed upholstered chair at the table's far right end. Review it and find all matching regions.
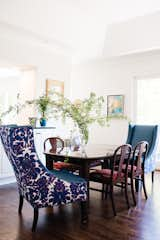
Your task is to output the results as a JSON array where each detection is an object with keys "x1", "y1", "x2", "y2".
[{"x1": 126, "y1": 124, "x2": 159, "y2": 182}]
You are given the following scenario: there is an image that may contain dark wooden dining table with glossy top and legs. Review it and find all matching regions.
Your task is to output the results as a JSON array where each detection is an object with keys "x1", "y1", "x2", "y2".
[{"x1": 44, "y1": 144, "x2": 117, "y2": 200}]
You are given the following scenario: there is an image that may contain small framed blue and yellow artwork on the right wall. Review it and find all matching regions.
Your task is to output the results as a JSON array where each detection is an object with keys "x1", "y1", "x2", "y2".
[{"x1": 107, "y1": 95, "x2": 124, "y2": 118}]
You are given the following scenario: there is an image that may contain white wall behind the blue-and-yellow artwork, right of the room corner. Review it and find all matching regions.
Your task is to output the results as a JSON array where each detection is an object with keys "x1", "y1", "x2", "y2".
[{"x1": 71, "y1": 51, "x2": 160, "y2": 144}]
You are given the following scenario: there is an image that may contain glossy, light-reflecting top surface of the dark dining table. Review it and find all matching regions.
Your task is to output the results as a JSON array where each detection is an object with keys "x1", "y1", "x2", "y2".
[{"x1": 44, "y1": 144, "x2": 117, "y2": 159}]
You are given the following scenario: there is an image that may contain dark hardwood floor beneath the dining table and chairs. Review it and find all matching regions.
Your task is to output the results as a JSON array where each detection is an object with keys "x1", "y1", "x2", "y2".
[{"x1": 0, "y1": 172, "x2": 160, "y2": 240}]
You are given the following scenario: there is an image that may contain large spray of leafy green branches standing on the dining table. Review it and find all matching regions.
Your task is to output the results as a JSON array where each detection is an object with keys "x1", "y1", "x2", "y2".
[{"x1": 51, "y1": 93, "x2": 109, "y2": 144}]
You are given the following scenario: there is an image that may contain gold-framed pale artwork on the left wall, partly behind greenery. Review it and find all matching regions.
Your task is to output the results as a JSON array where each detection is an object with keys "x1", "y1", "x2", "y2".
[{"x1": 46, "y1": 79, "x2": 64, "y2": 95}]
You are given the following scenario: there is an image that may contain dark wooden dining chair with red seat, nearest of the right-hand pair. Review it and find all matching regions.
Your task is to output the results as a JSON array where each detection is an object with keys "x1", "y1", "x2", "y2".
[{"x1": 89, "y1": 144, "x2": 132, "y2": 216}]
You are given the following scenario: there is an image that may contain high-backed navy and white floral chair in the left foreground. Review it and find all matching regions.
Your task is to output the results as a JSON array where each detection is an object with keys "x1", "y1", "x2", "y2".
[{"x1": 0, "y1": 126, "x2": 87, "y2": 231}]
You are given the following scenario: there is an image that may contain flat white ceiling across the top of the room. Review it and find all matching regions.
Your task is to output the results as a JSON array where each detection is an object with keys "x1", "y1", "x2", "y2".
[{"x1": 0, "y1": 0, "x2": 160, "y2": 60}]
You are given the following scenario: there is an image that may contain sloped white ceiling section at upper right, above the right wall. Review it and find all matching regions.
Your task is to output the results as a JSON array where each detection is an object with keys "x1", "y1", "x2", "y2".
[{"x1": 103, "y1": 11, "x2": 160, "y2": 57}]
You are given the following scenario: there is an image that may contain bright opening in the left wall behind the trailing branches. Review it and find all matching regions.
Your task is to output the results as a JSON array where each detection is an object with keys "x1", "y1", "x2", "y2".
[{"x1": 0, "y1": 66, "x2": 36, "y2": 125}]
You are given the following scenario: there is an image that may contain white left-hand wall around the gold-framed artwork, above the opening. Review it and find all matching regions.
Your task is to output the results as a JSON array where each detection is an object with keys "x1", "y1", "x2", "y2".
[{"x1": 0, "y1": 23, "x2": 71, "y2": 98}]
